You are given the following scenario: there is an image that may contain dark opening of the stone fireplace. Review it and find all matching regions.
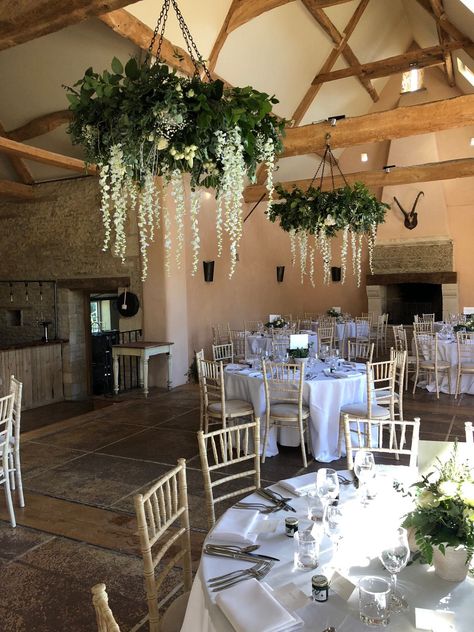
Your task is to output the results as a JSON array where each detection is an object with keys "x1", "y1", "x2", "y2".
[{"x1": 387, "y1": 283, "x2": 443, "y2": 325}]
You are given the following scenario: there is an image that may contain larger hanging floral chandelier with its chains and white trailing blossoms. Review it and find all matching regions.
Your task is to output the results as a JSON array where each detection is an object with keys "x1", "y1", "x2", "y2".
[{"x1": 66, "y1": 0, "x2": 285, "y2": 280}]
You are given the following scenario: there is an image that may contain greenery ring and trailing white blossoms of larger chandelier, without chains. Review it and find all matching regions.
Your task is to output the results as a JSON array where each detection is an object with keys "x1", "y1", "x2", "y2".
[{"x1": 66, "y1": 58, "x2": 285, "y2": 276}]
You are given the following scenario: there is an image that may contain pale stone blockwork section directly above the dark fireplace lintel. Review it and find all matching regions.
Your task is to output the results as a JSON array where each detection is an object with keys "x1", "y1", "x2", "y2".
[{"x1": 373, "y1": 239, "x2": 454, "y2": 274}]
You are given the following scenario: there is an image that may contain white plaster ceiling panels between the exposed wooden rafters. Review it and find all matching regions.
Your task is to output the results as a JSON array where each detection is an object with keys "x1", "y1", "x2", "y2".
[{"x1": 0, "y1": 0, "x2": 474, "y2": 181}]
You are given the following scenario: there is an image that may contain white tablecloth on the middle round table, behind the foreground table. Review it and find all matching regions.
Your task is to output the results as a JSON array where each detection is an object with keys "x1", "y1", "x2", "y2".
[{"x1": 225, "y1": 363, "x2": 367, "y2": 463}]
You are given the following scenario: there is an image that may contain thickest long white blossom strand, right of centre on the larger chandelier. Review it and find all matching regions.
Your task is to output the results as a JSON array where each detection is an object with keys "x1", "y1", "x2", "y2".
[{"x1": 215, "y1": 127, "x2": 245, "y2": 279}]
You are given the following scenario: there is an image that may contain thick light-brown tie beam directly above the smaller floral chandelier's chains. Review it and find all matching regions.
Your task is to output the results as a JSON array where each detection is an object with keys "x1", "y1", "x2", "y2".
[{"x1": 283, "y1": 94, "x2": 474, "y2": 157}]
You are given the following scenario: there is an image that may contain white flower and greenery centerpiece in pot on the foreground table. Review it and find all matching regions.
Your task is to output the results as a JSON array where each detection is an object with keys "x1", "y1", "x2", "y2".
[{"x1": 402, "y1": 444, "x2": 474, "y2": 581}]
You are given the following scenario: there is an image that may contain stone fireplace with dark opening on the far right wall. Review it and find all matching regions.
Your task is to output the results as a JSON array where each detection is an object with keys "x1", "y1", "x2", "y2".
[{"x1": 367, "y1": 239, "x2": 459, "y2": 324}]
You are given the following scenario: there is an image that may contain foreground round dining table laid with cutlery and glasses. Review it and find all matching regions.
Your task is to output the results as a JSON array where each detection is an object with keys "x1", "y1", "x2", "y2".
[{"x1": 181, "y1": 465, "x2": 474, "y2": 632}]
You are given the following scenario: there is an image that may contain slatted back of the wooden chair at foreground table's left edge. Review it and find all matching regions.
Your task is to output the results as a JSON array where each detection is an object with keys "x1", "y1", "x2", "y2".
[{"x1": 134, "y1": 459, "x2": 192, "y2": 632}]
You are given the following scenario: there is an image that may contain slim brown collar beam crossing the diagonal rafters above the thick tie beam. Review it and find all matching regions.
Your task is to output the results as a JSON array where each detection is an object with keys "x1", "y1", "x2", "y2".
[{"x1": 313, "y1": 40, "x2": 466, "y2": 83}]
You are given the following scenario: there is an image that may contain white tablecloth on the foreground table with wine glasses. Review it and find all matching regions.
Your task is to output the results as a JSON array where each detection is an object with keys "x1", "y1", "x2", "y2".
[{"x1": 181, "y1": 466, "x2": 474, "y2": 632}]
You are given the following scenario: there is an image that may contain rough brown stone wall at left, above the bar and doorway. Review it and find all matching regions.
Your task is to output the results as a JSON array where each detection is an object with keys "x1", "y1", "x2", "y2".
[{"x1": 0, "y1": 178, "x2": 142, "y2": 399}]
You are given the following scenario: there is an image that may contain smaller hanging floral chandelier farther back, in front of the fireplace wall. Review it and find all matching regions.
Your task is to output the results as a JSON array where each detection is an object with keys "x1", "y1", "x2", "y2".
[{"x1": 267, "y1": 142, "x2": 390, "y2": 287}]
